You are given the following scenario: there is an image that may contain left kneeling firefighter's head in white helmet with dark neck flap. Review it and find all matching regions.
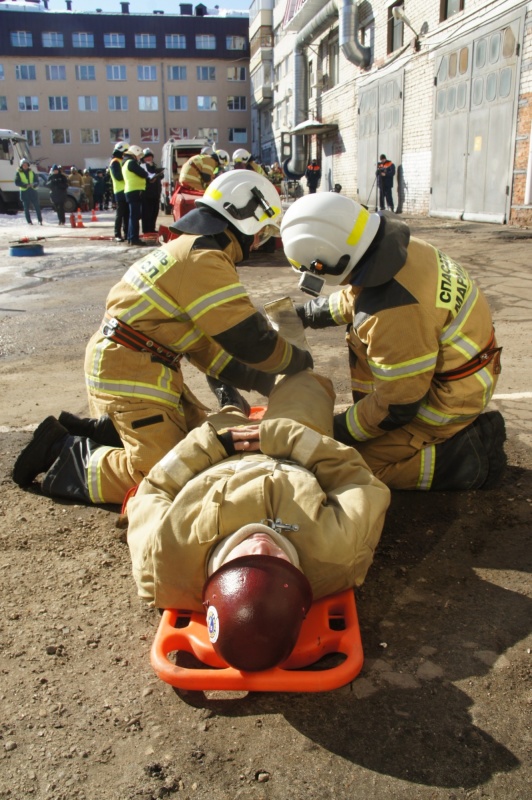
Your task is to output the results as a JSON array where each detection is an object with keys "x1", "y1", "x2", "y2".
[{"x1": 170, "y1": 171, "x2": 282, "y2": 252}]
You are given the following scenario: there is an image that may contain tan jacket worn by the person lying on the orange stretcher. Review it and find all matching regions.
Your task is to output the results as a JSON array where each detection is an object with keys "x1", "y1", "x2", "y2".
[{"x1": 128, "y1": 418, "x2": 390, "y2": 611}]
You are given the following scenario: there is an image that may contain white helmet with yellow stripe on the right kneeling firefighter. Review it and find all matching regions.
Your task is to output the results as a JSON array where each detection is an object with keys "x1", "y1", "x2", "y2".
[{"x1": 281, "y1": 192, "x2": 381, "y2": 294}]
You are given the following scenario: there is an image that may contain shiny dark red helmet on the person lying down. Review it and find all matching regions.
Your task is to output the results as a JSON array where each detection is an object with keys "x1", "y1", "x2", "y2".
[{"x1": 203, "y1": 556, "x2": 312, "y2": 672}]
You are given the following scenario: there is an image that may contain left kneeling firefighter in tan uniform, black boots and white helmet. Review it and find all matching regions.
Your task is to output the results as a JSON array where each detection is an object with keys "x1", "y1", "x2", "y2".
[{"x1": 13, "y1": 172, "x2": 312, "y2": 503}]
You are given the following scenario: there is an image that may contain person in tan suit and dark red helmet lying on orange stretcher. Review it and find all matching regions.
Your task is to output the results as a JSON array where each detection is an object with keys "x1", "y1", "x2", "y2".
[{"x1": 127, "y1": 370, "x2": 390, "y2": 670}]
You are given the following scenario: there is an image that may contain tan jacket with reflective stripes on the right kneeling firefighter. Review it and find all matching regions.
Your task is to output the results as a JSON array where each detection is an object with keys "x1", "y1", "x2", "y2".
[{"x1": 329, "y1": 238, "x2": 498, "y2": 442}]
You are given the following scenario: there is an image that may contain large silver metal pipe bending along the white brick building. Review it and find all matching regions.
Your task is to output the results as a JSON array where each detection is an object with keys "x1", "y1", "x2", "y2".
[{"x1": 283, "y1": 0, "x2": 371, "y2": 179}]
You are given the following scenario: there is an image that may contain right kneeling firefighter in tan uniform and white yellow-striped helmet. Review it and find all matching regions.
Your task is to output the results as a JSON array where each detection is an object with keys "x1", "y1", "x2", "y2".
[{"x1": 281, "y1": 193, "x2": 506, "y2": 490}]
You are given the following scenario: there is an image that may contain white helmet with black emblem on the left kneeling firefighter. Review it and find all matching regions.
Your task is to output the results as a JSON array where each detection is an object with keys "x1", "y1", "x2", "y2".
[{"x1": 196, "y1": 170, "x2": 283, "y2": 241}]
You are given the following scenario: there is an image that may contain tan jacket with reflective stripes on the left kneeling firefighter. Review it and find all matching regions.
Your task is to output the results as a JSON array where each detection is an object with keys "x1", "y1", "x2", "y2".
[{"x1": 85, "y1": 233, "x2": 301, "y2": 408}]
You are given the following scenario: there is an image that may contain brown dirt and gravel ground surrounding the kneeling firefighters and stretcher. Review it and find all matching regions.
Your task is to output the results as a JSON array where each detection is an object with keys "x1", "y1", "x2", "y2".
[{"x1": 0, "y1": 212, "x2": 532, "y2": 800}]
